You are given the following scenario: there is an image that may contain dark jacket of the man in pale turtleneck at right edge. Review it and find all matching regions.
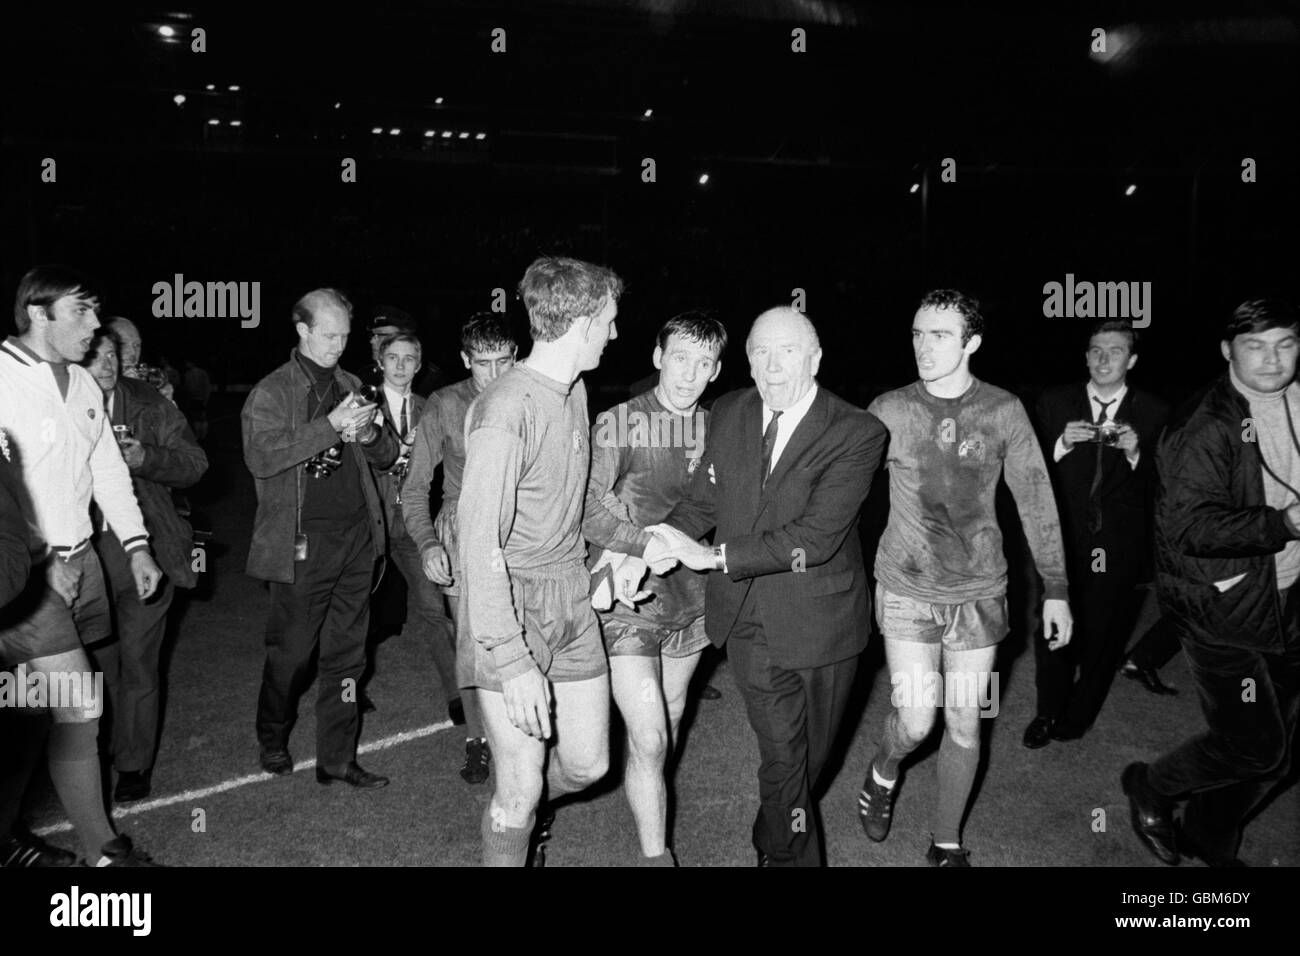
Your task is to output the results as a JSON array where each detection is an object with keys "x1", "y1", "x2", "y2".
[{"x1": 1156, "y1": 375, "x2": 1300, "y2": 653}]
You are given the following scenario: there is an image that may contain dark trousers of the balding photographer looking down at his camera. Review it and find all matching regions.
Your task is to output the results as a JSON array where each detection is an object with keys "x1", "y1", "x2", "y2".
[{"x1": 257, "y1": 522, "x2": 374, "y2": 769}]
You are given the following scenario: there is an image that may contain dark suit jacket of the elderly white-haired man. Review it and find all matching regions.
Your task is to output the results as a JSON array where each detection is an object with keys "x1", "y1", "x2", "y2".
[{"x1": 667, "y1": 386, "x2": 887, "y2": 670}]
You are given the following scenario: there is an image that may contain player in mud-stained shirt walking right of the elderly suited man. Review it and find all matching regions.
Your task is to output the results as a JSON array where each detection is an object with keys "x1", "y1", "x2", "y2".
[{"x1": 858, "y1": 289, "x2": 1073, "y2": 866}]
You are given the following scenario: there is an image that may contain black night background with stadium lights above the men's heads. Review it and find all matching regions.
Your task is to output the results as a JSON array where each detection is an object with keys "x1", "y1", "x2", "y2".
[{"x1": 0, "y1": 0, "x2": 1300, "y2": 402}]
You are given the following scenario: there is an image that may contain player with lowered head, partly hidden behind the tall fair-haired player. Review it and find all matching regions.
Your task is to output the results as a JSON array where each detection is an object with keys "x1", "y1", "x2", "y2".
[{"x1": 402, "y1": 312, "x2": 519, "y2": 783}]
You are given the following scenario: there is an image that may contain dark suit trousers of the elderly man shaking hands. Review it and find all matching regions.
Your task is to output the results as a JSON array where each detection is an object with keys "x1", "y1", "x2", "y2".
[{"x1": 728, "y1": 598, "x2": 858, "y2": 866}]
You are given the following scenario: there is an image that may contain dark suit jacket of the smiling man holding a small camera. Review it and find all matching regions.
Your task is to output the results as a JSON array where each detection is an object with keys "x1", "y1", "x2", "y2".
[{"x1": 1037, "y1": 384, "x2": 1169, "y2": 580}]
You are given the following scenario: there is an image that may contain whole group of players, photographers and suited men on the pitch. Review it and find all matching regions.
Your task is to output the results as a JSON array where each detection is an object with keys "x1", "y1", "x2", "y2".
[{"x1": 0, "y1": 258, "x2": 1300, "y2": 866}]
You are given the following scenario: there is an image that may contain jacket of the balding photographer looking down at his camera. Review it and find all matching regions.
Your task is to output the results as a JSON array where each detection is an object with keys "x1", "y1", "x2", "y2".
[{"x1": 241, "y1": 352, "x2": 398, "y2": 584}]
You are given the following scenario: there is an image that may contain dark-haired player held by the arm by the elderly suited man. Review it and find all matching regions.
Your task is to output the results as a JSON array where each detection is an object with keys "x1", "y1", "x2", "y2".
[{"x1": 582, "y1": 312, "x2": 727, "y2": 866}]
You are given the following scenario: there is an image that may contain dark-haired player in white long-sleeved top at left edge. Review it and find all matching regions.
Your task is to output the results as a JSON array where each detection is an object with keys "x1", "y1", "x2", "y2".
[{"x1": 0, "y1": 265, "x2": 163, "y2": 866}]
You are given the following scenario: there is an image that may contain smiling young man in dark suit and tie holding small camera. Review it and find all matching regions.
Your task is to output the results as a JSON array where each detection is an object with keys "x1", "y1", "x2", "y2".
[{"x1": 1024, "y1": 321, "x2": 1169, "y2": 749}]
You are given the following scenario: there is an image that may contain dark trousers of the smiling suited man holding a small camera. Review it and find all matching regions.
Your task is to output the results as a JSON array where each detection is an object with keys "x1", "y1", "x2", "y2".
[{"x1": 1034, "y1": 548, "x2": 1140, "y2": 731}]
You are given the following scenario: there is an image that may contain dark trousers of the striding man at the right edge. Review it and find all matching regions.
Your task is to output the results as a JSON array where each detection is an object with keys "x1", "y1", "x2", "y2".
[{"x1": 1147, "y1": 598, "x2": 1300, "y2": 858}]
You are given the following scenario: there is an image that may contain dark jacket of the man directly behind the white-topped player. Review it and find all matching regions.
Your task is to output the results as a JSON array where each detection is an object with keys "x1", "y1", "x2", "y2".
[{"x1": 100, "y1": 376, "x2": 208, "y2": 588}]
